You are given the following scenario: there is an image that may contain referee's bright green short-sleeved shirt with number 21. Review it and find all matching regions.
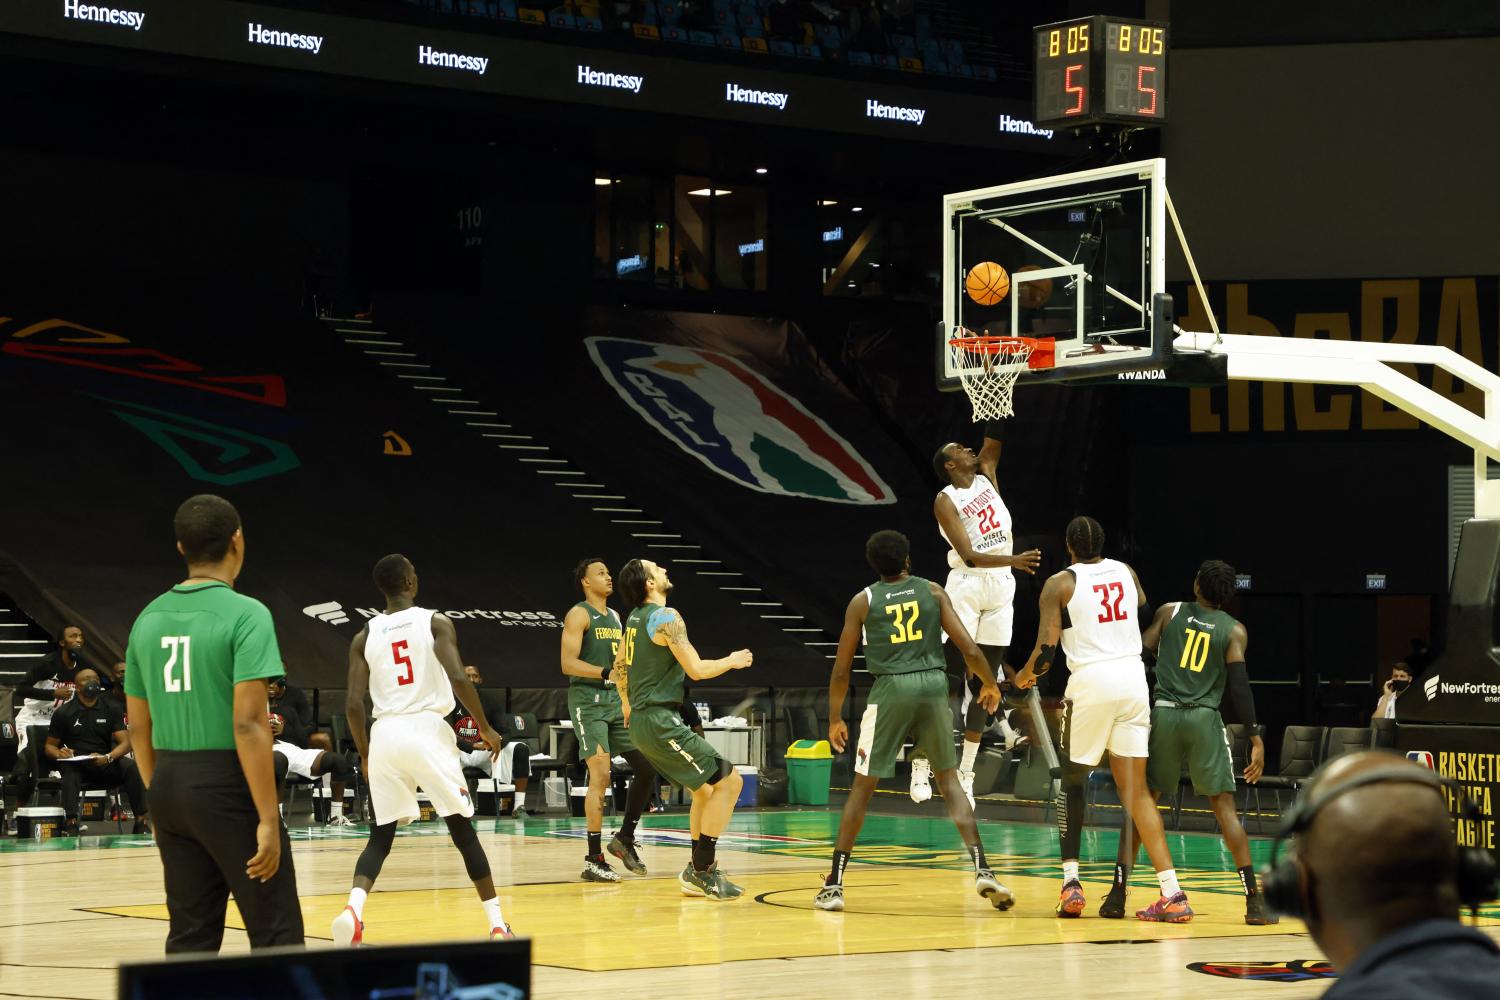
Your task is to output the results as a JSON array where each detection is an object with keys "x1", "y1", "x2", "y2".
[{"x1": 125, "y1": 583, "x2": 287, "y2": 750}]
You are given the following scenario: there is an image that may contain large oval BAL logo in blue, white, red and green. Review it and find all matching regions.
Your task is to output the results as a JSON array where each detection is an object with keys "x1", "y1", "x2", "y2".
[{"x1": 585, "y1": 337, "x2": 896, "y2": 504}]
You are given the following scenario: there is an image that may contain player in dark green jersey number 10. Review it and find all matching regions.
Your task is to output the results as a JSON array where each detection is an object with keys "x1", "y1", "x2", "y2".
[{"x1": 1100, "y1": 559, "x2": 1277, "y2": 925}]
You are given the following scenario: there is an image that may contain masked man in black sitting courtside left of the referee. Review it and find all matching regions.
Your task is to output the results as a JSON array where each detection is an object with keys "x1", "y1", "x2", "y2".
[{"x1": 45, "y1": 667, "x2": 150, "y2": 837}]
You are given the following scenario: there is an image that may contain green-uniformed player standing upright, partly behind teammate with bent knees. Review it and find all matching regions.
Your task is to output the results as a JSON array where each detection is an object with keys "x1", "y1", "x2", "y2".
[{"x1": 563, "y1": 558, "x2": 656, "y2": 882}]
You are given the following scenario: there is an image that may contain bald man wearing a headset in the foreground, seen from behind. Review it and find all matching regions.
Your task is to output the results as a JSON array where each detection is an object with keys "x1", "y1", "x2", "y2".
[{"x1": 1265, "y1": 751, "x2": 1500, "y2": 1000}]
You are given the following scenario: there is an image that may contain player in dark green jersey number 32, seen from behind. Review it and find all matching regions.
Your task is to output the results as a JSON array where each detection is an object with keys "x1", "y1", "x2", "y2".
[{"x1": 813, "y1": 531, "x2": 1014, "y2": 910}]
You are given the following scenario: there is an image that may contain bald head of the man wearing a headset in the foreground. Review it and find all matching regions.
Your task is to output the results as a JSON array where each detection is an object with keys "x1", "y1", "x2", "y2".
[{"x1": 1298, "y1": 751, "x2": 1458, "y2": 948}]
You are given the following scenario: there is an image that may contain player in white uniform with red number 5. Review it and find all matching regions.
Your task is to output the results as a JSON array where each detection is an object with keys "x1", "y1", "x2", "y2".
[{"x1": 333, "y1": 555, "x2": 515, "y2": 945}]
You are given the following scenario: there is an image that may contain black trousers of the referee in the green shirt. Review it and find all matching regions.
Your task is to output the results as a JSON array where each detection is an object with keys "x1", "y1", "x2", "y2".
[{"x1": 152, "y1": 750, "x2": 303, "y2": 954}]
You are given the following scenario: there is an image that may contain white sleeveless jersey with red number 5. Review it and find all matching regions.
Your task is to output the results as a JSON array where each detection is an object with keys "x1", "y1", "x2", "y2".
[{"x1": 365, "y1": 607, "x2": 453, "y2": 718}]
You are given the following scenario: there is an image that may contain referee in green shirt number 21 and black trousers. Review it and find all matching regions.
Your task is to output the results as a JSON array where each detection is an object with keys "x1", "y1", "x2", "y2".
[{"x1": 125, "y1": 493, "x2": 303, "y2": 952}]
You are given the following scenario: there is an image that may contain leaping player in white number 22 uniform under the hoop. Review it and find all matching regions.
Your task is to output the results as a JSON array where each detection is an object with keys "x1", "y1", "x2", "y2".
[{"x1": 911, "y1": 420, "x2": 1041, "y2": 808}]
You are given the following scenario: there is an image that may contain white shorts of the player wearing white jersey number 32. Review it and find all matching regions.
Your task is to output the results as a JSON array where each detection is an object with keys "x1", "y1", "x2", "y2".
[{"x1": 1062, "y1": 657, "x2": 1151, "y2": 768}]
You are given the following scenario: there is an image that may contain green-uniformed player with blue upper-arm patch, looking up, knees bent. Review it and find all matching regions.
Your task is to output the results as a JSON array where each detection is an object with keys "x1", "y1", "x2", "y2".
[{"x1": 611, "y1": 559, "x2": 755, "y2": 900}]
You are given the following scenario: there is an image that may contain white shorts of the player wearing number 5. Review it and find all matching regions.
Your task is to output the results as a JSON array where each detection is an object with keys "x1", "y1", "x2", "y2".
[{"x1": 366, "y1": 712, "x2": 474, "y2": 826}]
